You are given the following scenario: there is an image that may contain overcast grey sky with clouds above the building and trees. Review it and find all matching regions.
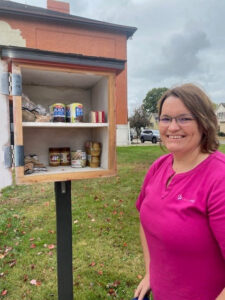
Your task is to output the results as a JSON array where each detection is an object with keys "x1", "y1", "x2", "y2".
[{"x1": 14, "y1": 0, "x2": 225, "y2": 114}]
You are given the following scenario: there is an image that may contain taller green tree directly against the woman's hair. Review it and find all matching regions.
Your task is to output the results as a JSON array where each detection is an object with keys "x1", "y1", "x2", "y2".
[{"x1": 143, "y1": 87, "x2": 168, "y2": 113}]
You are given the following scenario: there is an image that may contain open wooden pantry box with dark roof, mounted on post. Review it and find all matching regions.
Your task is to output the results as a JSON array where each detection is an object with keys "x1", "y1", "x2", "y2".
[{"x1": 0, "y1": 47, "x2": 125, "y2": 185}]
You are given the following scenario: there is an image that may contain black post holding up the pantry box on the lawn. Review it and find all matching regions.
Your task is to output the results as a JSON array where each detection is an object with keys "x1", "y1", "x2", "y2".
[{"x1": 55, "y1": 181, "x2": 73, "y2": 300}]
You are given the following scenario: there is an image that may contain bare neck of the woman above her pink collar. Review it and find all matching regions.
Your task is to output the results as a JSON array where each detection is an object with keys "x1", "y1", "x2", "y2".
[{"x1": 173, "y1": 148, "x2": 209, "y2": 174}]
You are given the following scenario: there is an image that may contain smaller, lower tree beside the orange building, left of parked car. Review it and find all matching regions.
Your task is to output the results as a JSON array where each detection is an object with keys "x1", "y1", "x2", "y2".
[{"x1": 129, "y1": 105, "x2": 149, "y2": 138}]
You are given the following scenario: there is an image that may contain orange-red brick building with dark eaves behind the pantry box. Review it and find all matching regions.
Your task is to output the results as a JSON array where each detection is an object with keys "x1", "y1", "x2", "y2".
[{"x1": 0, "y1": 0, "x2": 136, "y2": 145}]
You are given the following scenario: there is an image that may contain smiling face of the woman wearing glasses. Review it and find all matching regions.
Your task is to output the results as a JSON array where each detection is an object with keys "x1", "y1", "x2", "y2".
[{"x1": 159, "y1": 96, "x2": 202, "y2": 154}]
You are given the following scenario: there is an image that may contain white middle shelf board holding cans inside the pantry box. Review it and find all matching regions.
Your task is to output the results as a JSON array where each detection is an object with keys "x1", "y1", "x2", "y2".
[{"x1": 22, "y1": 122, "x2": 109, "y2": 128}]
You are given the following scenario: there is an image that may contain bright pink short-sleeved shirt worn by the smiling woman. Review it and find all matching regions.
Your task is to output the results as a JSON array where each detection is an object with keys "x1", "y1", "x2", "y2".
[{"x1": 136, "y1": 151, "x2": 225, "y2": 300}]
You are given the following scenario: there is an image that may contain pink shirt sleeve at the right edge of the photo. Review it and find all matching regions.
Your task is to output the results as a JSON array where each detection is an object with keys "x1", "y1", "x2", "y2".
[{"x1": 208, "y1": 178, "x2": 225, "y2": 259}]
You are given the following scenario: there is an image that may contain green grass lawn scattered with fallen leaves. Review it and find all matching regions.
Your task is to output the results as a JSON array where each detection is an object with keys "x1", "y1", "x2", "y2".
[{"x1": 0, "y1": 145, "x2": 225, "y2": 300}]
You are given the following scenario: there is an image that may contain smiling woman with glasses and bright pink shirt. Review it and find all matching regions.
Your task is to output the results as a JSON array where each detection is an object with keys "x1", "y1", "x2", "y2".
[{"x1": 134, "y1": 84, "x2": 225, "y2": 300}]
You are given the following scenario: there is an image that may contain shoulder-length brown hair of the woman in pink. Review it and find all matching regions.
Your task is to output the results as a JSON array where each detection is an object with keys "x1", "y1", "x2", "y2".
[{"x1": 158, "y1": 83, "x2": 219, "y2": 153}]
